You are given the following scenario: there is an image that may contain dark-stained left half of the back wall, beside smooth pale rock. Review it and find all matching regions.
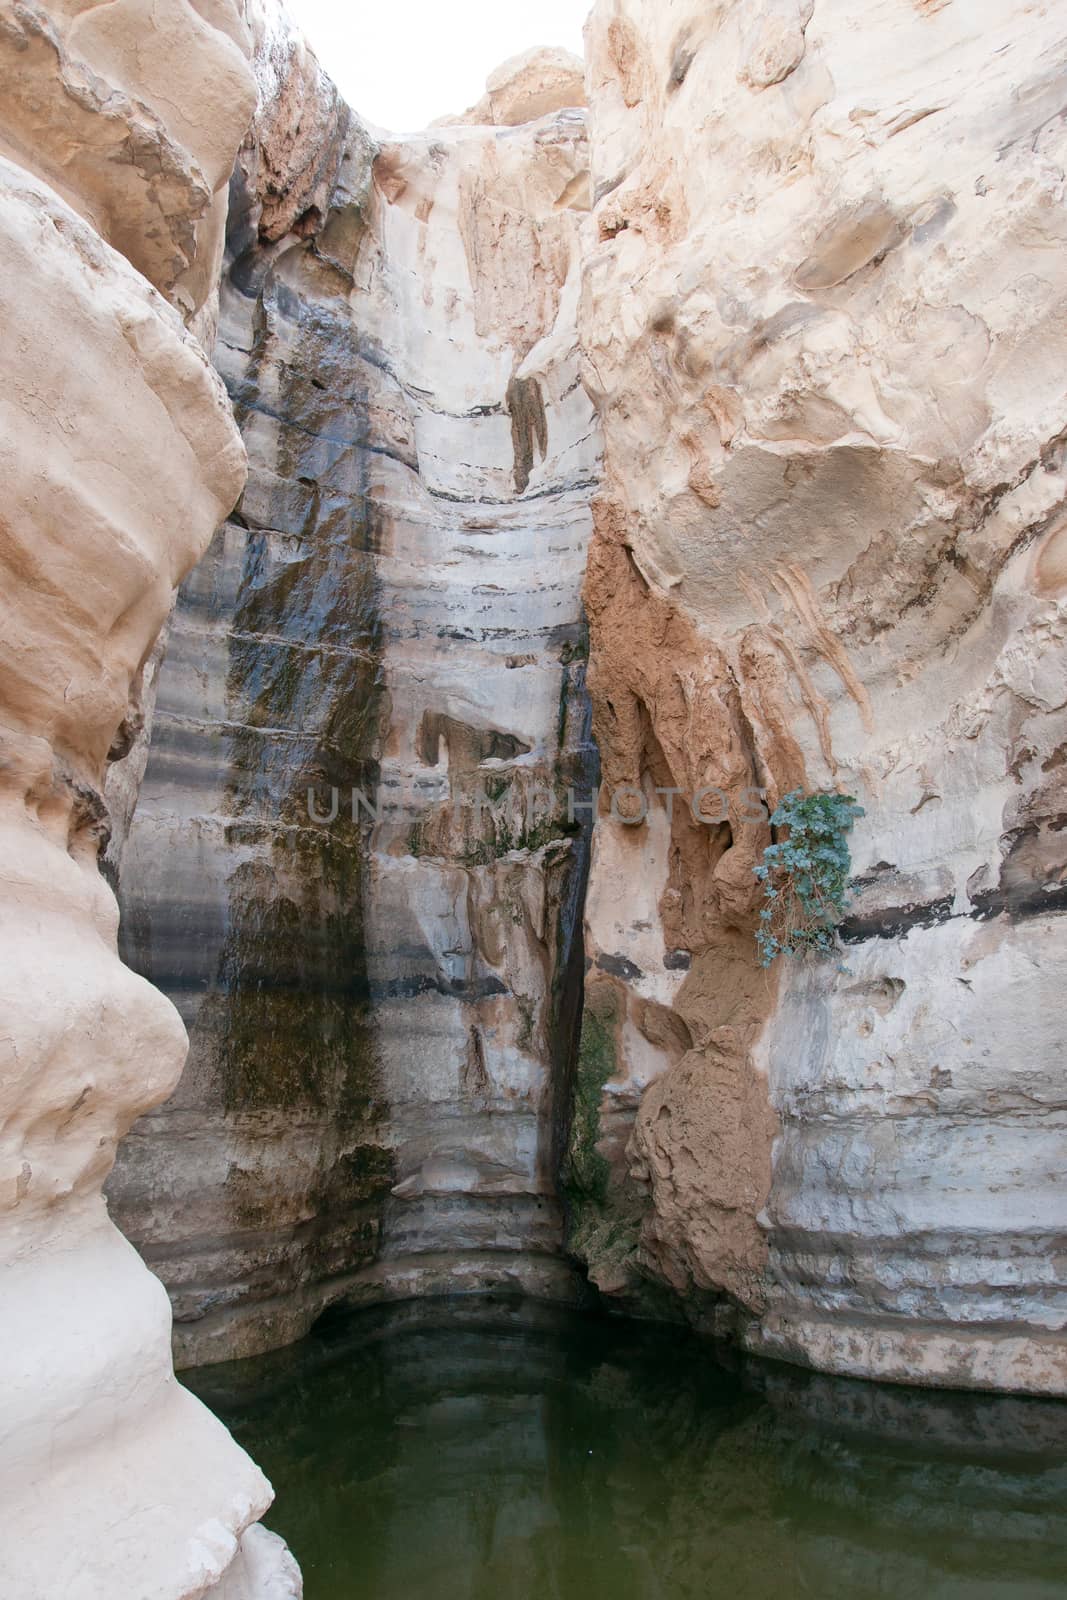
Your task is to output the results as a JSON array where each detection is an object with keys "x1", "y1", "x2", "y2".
[{"x1": 110, "y1": 147, "x2": 394, "y2": 1360}]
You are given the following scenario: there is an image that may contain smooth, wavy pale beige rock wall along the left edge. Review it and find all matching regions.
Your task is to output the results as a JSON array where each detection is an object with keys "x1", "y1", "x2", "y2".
[{"x1": 0, "y1": 0, "x2": 299, "y2": 1600}]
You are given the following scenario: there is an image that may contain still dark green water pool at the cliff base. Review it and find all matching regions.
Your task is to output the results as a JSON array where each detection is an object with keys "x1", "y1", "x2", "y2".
[{"x1": 186, "y1": 1301, "x2": 1067, "y2": 1600}]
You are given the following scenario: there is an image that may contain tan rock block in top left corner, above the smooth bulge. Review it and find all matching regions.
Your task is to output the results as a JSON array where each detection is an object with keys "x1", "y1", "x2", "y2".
[{"x1": 0, "y1": 0, "x2": 256, "y2": 317}]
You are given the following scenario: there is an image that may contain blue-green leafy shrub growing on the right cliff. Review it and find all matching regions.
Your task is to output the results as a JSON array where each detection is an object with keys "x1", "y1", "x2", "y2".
[{"x1": 752, "y1": 789, "x2": 864, "y2": 966}]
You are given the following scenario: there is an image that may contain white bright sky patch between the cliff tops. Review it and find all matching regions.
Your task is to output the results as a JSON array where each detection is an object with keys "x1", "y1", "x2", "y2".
[{"x1": 286, "y1": 0, "x2": 592, "y2": 133}]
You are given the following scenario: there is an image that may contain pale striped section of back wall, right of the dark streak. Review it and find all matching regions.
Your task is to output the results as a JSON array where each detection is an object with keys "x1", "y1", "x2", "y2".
[{"x1": 368, "y1": 112, "x2": 600, "y2": 1324}]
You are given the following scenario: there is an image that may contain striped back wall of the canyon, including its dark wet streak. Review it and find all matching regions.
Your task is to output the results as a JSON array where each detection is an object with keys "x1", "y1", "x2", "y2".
[{"x1": 109, "y1": 18, "x2": 598, "y2": 1363}]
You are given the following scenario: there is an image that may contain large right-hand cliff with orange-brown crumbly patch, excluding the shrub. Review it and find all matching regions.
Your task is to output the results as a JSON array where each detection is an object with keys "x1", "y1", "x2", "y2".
[{"x1": 569, "y1": 0, "x2": 1067, "y2": 1392}]
